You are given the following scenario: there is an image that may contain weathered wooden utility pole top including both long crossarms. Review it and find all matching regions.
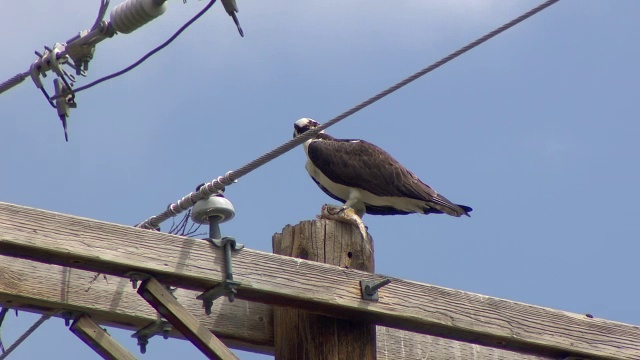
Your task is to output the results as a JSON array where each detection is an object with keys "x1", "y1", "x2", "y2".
[{"x1": 0, "y1": 203, "x2": 640, "y2": 360}]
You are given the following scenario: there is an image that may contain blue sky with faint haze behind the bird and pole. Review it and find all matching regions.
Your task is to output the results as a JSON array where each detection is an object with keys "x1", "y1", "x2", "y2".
[{"x1": 0, "y1": 0, "x2": 640, "y2": 359}]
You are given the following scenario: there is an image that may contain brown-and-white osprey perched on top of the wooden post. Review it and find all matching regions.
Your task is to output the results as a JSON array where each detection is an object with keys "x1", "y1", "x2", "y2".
[{"x1": 293, "y1": 118, "x2": 472, "y2": 217}]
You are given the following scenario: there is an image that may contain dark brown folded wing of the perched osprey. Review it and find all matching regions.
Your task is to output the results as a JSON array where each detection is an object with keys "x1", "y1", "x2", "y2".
[{"x1": 307, "y1": 140, "x2": 466, "y2": 216}]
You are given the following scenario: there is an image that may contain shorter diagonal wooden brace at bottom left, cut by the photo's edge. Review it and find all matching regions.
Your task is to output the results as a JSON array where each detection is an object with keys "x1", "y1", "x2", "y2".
[{"x1": 69, "y1": 315, "x2": 136, "y2": 360}]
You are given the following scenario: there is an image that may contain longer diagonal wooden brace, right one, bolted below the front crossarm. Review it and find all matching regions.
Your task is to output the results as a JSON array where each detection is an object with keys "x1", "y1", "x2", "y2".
[{"x1": 138, "y1": 277, "x2": 238, "y2": 360}]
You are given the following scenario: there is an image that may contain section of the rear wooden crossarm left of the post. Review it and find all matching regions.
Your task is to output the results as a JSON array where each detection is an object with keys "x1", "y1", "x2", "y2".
[{"x1": 0, "y1": 255, "x2": 273, "y2": 354}]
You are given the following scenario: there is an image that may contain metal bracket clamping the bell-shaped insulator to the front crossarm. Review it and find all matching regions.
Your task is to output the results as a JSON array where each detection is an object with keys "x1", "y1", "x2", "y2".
[{"x1": 196, "y1": 237, "x2": 244, "y2": 315}]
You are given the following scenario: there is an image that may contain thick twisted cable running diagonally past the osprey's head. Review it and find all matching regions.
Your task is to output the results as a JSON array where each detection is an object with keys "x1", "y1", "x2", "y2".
[{"x1": 136, "y1": 0, "x2": 560, "y2": 229}]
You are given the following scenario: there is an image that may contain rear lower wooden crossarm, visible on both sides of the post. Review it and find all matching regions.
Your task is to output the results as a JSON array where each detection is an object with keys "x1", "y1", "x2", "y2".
[{"x1": 0, "y1": 255, "x2": 557, "y2": 360}]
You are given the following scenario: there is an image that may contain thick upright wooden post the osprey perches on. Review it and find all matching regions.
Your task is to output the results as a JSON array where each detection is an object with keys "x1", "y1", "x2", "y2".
[{"x1": 273, "y1": 220, "x2": 376, "y2": 360}]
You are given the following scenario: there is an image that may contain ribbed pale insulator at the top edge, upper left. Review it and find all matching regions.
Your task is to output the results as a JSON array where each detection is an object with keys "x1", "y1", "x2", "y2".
[{"x1": 109, "y1": 0, "x2": 167, "y2": 34}]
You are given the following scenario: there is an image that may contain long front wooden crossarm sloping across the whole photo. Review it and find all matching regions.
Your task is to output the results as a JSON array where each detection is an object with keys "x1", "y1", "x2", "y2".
[{"x1": 0, "y1": 204, "x2": 640, "y2": 359}]
